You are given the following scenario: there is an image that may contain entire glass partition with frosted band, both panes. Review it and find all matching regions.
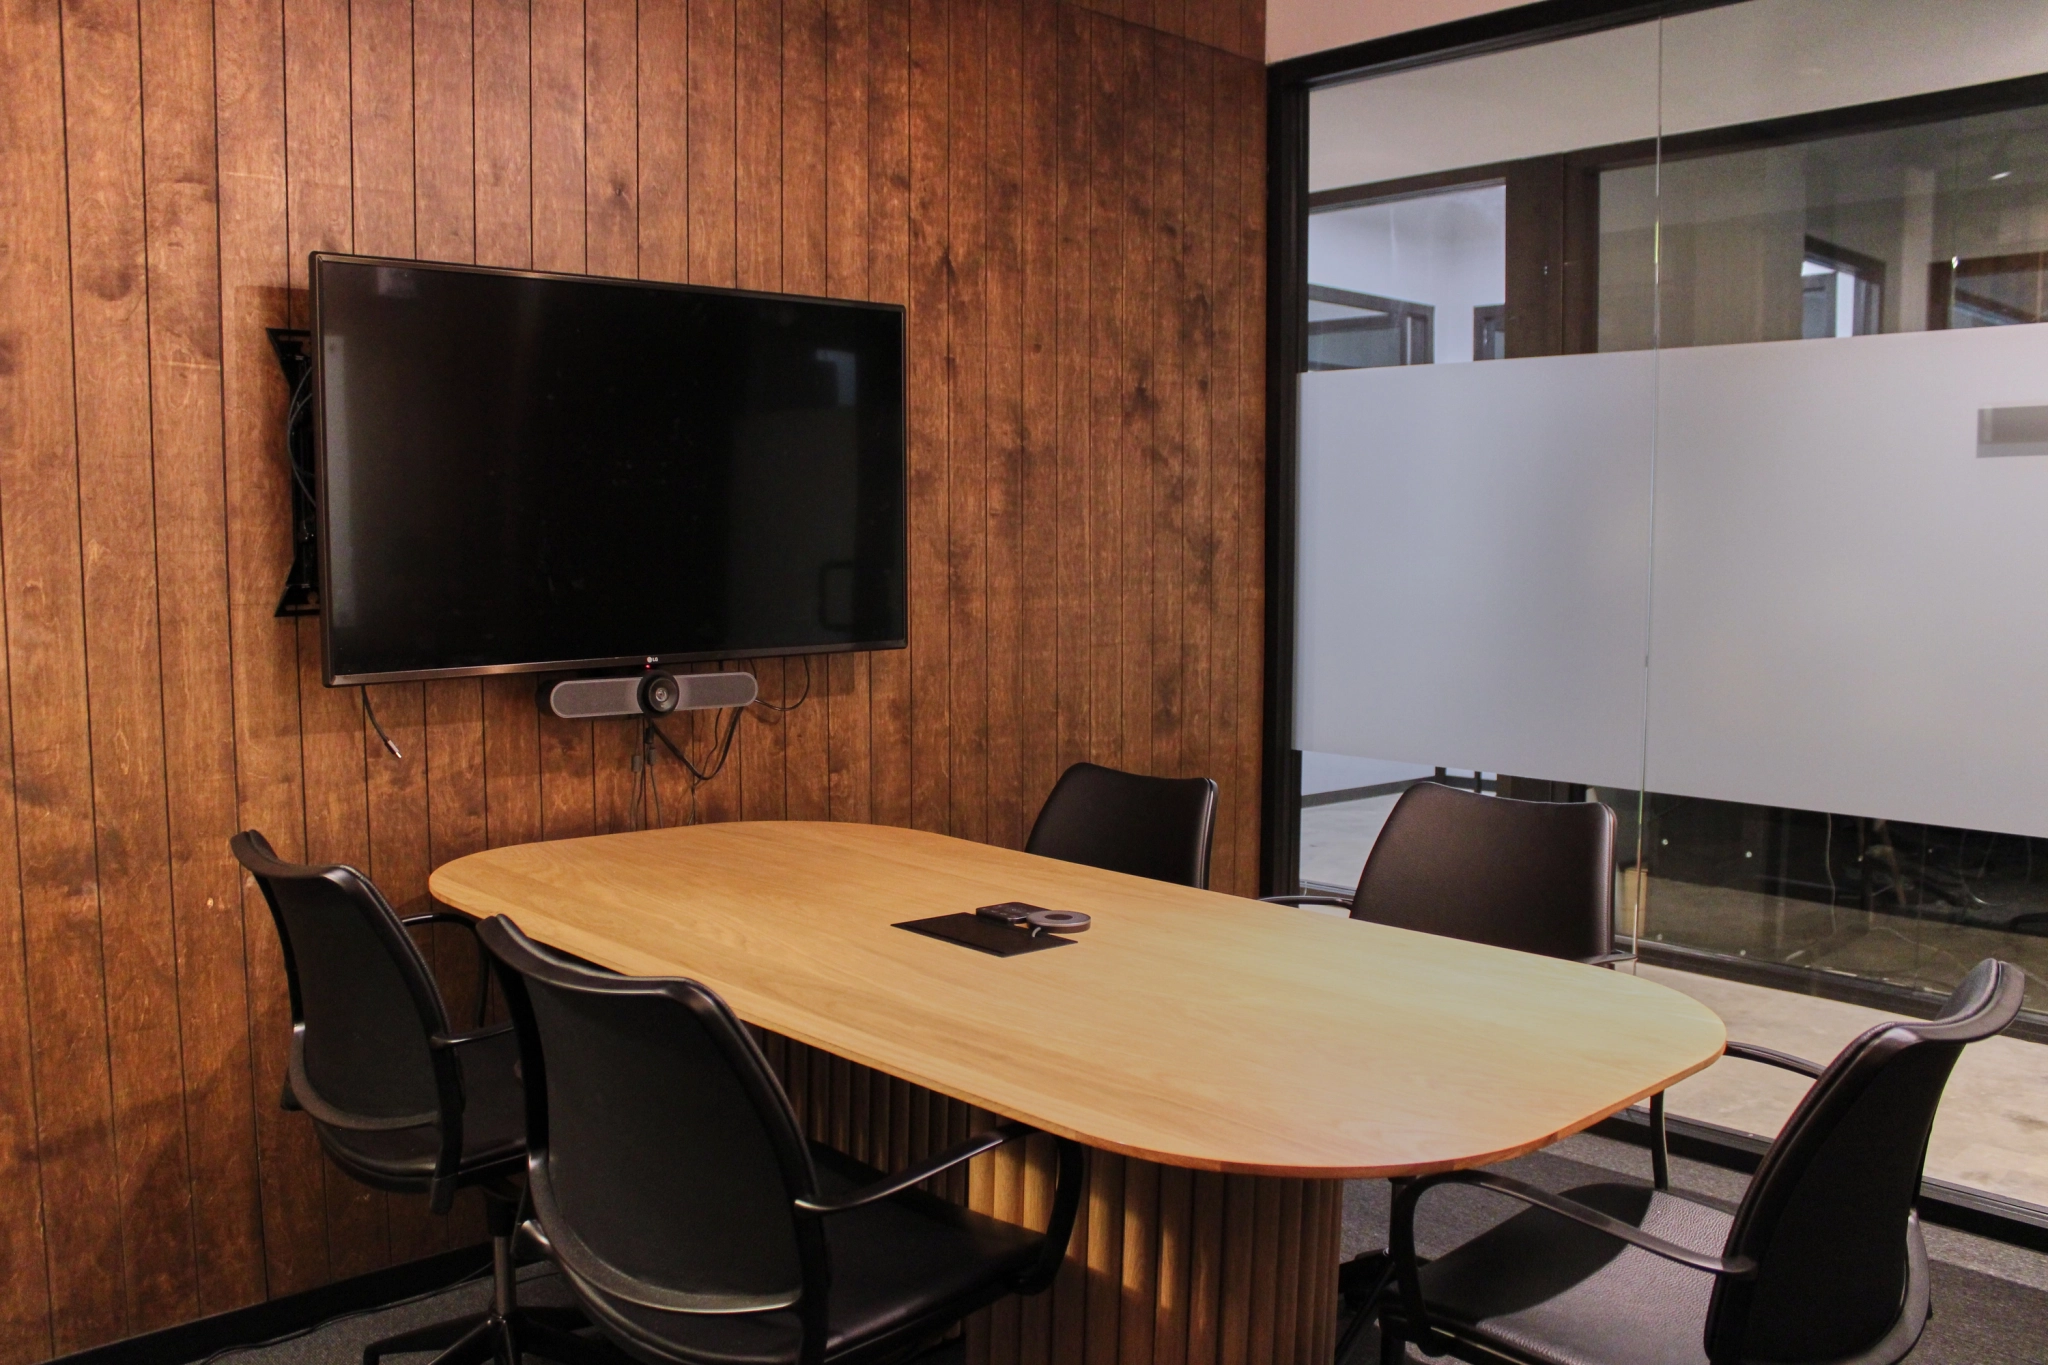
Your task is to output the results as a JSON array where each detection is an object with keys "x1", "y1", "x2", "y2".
[{"x1": 1294, "y1": 0, "x2": 2048, "y2": 1207}]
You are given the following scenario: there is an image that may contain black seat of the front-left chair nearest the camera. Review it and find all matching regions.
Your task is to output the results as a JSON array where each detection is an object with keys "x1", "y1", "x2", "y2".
[{"x1": 565, "y1": 1150, "x2": 1044, "y2": 1365}]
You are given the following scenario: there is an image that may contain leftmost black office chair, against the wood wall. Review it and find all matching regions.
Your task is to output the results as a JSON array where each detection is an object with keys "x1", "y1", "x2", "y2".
[{"x1": 227, "y1": 829, "x2": 596, "y2": 1365}]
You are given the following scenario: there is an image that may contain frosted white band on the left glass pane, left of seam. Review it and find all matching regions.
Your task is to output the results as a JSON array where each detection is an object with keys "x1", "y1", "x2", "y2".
[{"x1": 1294, "y1": 352, "x2": 1654, "y2": 788}]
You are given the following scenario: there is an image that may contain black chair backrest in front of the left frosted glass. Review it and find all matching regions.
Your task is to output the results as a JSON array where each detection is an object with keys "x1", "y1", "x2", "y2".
[{"x1": 1352, "y1": 782, "x2": 1614, "y2": 960}]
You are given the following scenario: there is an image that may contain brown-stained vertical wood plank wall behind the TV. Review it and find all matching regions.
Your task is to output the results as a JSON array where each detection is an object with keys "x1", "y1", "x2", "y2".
[{"x1": 0, "y1": 0, "x2": 1264, "y2": 1365}]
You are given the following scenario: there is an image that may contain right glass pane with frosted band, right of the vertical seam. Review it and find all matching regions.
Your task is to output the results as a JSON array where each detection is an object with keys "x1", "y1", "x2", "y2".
[{"x1": 1638, "y1": 0, "x2": 2048, "y2": 1035}]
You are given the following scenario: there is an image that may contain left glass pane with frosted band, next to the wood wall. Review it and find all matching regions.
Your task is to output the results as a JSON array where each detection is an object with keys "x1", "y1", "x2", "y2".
[{"x1": 1296, "y1": 25, "x2": 1657, "y2": 890}]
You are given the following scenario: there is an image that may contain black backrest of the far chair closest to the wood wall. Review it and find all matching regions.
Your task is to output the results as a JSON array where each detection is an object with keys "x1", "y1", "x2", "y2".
[{"x1": 1024, "y1": 763, "x2": 1217, "y2": 888}]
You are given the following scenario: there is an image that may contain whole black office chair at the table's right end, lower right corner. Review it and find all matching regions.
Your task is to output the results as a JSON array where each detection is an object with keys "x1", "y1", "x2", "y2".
[{"x1": 1380, "y1": 958, "x2": 2025, "y2": 1365}]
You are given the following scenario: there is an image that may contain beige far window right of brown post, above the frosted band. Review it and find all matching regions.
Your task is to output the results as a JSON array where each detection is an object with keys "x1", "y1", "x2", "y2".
[{"x1": 1599, "y1": 108, "x2": 2048, "y2": 350}]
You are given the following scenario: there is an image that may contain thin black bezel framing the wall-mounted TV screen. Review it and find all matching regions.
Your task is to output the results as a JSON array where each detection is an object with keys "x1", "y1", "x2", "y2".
[{"x1": 305, "y1": 252, "x2": 909, "y2": 688}]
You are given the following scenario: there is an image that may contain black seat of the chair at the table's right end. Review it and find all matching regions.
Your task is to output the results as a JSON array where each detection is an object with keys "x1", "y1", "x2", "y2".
[{"x1": 1384, "y1": 1183, "x2": 1731, "y2": 1365}]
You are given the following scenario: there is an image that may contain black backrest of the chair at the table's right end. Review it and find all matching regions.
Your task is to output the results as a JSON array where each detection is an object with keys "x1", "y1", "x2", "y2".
[{"x1": 1706, "y1": 958, "x2": 2025, "y2": 1361}]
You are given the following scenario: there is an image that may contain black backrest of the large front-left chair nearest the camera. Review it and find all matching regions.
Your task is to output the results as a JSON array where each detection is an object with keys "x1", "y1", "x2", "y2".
[{"x1": 479, "y1": 915, "x2": 829, "y2": 1314}]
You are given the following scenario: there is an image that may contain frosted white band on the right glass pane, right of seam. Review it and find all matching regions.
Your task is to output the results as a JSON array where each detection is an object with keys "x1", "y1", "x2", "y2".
[{"x1": 1654, "y1": 327, "x2": 2048, "y2": 835}]
